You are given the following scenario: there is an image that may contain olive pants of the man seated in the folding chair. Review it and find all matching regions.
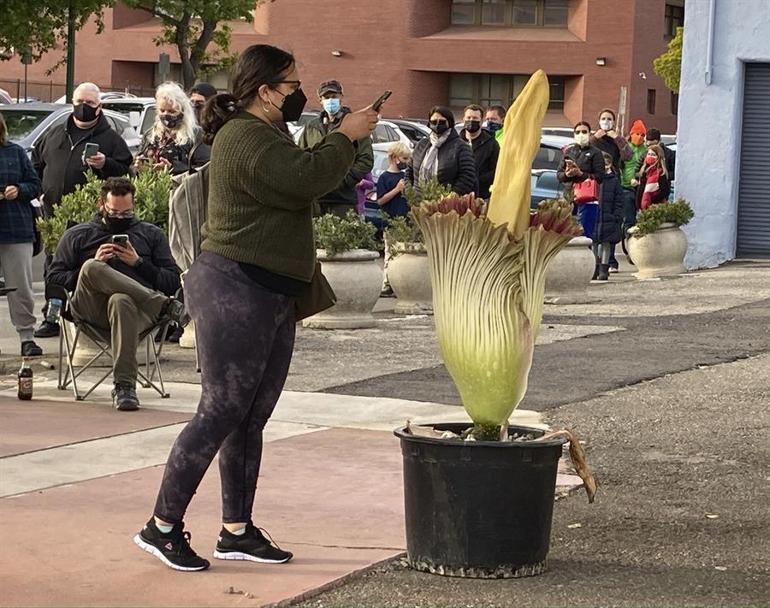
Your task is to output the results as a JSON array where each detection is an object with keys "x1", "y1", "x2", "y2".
[{"x1": 71, "y1": 260, "x2": 168, "y2": 386}]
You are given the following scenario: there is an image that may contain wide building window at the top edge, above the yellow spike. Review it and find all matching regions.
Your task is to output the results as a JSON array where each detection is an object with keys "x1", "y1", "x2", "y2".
[{"x1": 452, "y1": 0, "x2": 570, "y2": 27}]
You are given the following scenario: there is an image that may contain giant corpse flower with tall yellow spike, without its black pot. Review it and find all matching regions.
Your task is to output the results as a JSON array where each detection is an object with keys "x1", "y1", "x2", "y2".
[{"x1": 414, "y1": 70, "x2": 581, "y2": 438}]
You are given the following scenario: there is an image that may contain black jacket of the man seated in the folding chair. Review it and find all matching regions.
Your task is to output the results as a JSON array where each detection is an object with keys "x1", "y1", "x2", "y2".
[{"x1": 45, "y1": 214, "x2": 181, "y2": 296}]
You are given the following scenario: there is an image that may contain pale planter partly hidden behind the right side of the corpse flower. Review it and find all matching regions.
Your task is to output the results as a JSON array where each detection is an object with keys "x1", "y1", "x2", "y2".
[{"x1": 545, "y1": 236, "x2": 596, "y2": 302}]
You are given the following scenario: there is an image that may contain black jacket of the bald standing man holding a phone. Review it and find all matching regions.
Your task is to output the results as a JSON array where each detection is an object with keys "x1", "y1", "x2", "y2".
[{"x1": 32, "y1": 114, "x2": 133, "y2": 217}]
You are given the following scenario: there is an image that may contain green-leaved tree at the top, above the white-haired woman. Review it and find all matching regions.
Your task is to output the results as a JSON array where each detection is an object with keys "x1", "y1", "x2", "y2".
[{"x1": 124, "y1": 0, "x2": 272, "y2": 89}]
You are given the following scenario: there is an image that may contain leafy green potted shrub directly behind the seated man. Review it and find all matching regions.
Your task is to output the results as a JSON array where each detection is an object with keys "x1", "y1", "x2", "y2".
[{"x1": 37, "y1": 170, "x2": 171, "y2": 365}]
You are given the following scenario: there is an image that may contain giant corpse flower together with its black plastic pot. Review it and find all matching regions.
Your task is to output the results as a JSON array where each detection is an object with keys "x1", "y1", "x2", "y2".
[{"x1": 395, "y1": 71, "x2": 595, "y2": 577}]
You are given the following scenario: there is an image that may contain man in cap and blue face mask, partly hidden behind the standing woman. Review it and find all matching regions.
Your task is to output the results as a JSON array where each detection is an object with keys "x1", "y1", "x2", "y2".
[{"x1": 297, "y1": 80, "x2": 374, "y2": 217}]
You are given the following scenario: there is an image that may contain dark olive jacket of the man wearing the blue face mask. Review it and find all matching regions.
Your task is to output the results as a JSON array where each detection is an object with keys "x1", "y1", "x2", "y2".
[{"x1": 297, "y1": 108, "x2": 374, "y2": 209}]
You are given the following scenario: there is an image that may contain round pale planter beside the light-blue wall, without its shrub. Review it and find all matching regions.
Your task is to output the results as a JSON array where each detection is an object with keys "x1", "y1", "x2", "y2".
[{"x1": 628, "y1": 223, "x2": 687, "y2": 279}]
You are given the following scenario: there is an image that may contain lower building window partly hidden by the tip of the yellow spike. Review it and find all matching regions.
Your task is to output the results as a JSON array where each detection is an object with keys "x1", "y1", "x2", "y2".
[{"x1": 449, "y1": 74, "x2": 564, "y2": 112}]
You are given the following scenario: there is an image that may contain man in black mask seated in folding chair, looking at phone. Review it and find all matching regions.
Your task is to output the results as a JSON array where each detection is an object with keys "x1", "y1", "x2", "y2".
[{"x1": 46, "y1": 177, "x2": 189, "y2": 411}]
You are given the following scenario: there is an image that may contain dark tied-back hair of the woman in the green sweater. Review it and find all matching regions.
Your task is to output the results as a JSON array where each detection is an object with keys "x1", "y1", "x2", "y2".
[{"x1": 201, "y1": 44, "x2": 294, "y2": 143}]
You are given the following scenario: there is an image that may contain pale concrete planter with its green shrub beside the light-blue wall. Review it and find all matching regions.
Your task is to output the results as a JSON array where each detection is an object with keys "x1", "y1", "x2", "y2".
[{"x1": 628, "y1": 198, "x2": 694, "y2": 279}]
